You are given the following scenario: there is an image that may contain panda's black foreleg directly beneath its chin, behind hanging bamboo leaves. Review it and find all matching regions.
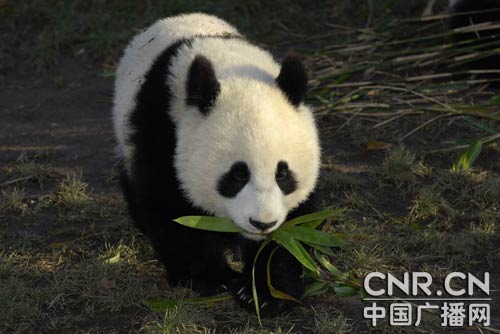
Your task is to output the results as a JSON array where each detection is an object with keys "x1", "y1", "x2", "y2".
[{"x1": 232, "y1": 241, "x2": 304, "y2": 316}]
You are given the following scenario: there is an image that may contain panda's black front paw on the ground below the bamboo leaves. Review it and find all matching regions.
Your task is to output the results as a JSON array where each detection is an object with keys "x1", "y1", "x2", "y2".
[{"x1": 231, "y1": 281, "x2": 296, "y2": 317}]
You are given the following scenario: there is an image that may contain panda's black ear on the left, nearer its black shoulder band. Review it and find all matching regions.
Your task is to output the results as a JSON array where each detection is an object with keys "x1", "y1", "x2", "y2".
[{"x1": 186, "y1": 55, "x2": 220, "y2": 115}]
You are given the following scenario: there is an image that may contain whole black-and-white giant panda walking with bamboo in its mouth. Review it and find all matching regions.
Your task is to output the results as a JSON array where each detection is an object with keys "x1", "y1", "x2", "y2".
[{"x1": 113, "y1": 13, "x2": 320, "y2": 316}]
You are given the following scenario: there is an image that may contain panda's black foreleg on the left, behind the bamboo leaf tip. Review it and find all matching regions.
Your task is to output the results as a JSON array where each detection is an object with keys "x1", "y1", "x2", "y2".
[{"x1": 124, "y1": 187, "x2": 239, "y2": 295}]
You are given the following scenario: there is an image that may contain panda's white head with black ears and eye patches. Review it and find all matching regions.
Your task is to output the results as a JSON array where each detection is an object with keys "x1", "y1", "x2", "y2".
[{"x1": 175, "y1": 55, "x2": 320, "y2": 240}]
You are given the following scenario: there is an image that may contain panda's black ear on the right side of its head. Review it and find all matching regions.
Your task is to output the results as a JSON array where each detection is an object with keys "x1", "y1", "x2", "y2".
[{"x1": 276, "y1": 53, "x2": 307, "y2": 107}]
